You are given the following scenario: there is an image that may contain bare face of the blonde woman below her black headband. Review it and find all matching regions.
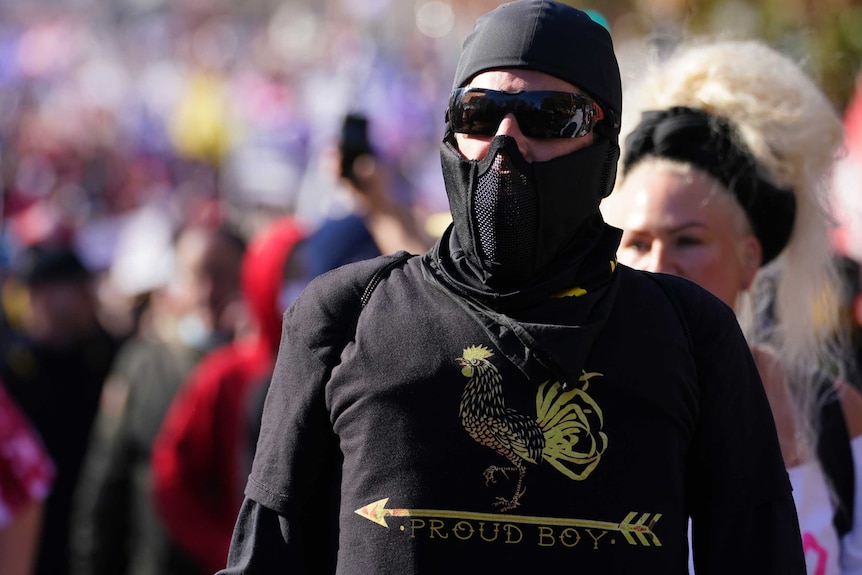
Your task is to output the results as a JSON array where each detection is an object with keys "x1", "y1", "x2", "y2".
[{"x1": 618, "y1": 163, "x2": 761, "y2": 307}]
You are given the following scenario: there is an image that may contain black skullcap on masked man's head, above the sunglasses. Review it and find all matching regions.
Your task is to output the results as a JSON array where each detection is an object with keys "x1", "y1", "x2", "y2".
[{"x1": 454, "y1": 0, "x2": 623, "y2": 124}]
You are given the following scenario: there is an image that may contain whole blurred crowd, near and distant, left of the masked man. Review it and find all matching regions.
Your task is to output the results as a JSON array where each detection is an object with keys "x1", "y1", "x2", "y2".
[{"x1": 0, "y1": 0, "x2": 862, "y2": 575}]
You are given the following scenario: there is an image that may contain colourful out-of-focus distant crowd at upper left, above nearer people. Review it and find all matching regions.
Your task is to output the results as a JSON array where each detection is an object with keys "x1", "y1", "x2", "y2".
[{"x1": 0, "y1": 2, "x2": 456, "y2": 280}]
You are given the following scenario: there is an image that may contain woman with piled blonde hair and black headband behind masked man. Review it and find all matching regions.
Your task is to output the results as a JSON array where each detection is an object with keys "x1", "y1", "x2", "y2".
[{"x1": 603, "y1": 41, "x2": 862, "y2": 575}]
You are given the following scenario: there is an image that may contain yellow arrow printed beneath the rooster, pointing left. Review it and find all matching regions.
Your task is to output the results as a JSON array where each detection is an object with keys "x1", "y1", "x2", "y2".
[{"x1": 356, "y1": 497, "x2": 661, "y2": 547}]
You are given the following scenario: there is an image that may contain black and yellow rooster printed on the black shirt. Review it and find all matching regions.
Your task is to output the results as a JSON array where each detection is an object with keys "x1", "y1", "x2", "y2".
[{"x1": 457, "y1": 346, "x2": 608, "y2": 512}]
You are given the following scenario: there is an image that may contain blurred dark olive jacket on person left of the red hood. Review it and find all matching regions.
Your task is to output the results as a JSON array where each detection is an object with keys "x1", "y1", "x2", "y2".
[{"x1": 70, "y1": 336, "x2": 204, "y2": 575}]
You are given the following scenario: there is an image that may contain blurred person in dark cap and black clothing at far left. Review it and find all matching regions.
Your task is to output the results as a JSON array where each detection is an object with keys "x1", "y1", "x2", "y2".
[{"x1": 0, "y1": 242, "x2": 122, "y2": 575}]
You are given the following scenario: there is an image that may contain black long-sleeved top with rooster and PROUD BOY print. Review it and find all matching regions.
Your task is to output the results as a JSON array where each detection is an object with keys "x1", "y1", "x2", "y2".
[{"x1": 222, "y1": 222, "x2": 805, "y2": 575}]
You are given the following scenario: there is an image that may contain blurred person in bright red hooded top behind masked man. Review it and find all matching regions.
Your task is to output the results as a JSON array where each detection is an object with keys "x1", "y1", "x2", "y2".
[{"x1": 152, "y1": 217, "x2": 306, "y2": 573}]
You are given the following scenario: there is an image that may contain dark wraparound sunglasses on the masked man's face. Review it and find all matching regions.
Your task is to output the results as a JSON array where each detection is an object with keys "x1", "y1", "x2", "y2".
[{"x1": 446, "y1": 88, "x2": 617, "y2": 138}]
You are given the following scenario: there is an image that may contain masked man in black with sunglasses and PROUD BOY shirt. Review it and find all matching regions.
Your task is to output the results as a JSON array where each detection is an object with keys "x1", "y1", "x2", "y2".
[{"x1": 220, "y1": 0, "x2": 805, "y2": 575}]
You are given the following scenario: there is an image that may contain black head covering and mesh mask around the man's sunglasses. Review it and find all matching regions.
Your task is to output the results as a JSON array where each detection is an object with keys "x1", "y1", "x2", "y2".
[{"x1": 441, "y1": 0, "x2": 622, "y2": 286}]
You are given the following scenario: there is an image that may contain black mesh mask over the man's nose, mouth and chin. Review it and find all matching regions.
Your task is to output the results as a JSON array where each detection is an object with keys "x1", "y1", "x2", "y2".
[{"x1": 440, "y1": 136, "x2": 618, "y2": 284}]
